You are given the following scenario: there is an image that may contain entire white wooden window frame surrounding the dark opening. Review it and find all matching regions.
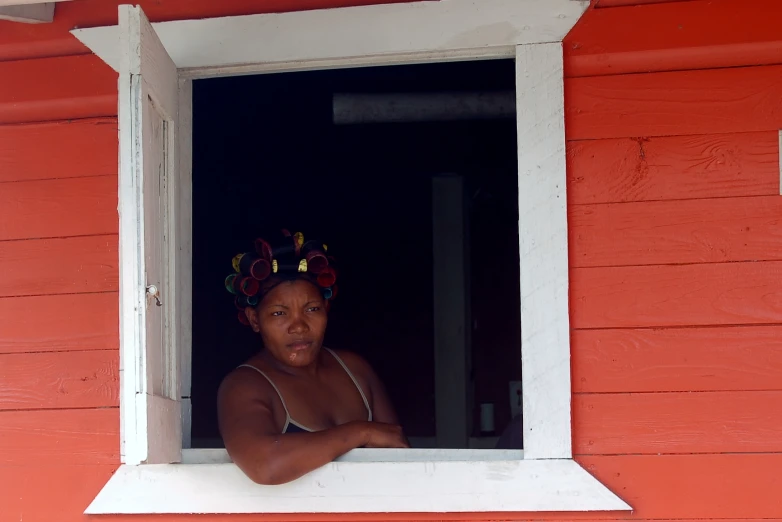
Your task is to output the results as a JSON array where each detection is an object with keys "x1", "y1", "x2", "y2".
[{"x1": 72, "y1": 0, "x2": 631, "y2": 514}]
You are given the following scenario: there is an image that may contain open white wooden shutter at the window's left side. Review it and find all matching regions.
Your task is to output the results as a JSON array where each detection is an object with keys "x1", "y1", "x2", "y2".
[{"x1": 119, "y1": 5, "x2": 182, "y2": 464}]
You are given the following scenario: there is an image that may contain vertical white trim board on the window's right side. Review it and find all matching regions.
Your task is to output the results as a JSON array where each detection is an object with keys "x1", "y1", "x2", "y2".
[{"x1": 516, "y1": 43, "x2": 571, "y2": 459}]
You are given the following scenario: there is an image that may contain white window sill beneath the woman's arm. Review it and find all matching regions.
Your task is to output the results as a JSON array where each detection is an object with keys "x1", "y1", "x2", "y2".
[{"x1": 85, "y1": 450, "x2": 631, "y2": 514}]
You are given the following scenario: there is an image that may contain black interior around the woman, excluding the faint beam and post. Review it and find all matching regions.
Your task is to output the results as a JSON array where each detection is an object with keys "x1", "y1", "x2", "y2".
[{"x1": 192, "y1": 60, "x2": 521, "y2": 447}]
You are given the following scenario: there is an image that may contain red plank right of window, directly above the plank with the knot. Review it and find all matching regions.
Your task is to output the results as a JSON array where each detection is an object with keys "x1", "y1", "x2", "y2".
[{"x1": 565, "y1": 66, "x2": 782, "y2": 140}]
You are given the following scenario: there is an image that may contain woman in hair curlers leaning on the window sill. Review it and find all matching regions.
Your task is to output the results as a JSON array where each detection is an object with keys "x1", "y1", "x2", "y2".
[{"x1": 218, "y1": 231, "x2": 409, "y2": 484}]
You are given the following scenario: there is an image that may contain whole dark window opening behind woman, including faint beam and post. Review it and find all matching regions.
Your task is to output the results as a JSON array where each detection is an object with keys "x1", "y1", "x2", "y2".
[{"x1": 185, "y1": 59, "x2": 522, "y2": 450}]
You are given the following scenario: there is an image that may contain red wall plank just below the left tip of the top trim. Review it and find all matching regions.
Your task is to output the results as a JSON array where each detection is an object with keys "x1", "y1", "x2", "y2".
[{"x1": 0, "y1": 54, "x2": 117, "y2": 124}]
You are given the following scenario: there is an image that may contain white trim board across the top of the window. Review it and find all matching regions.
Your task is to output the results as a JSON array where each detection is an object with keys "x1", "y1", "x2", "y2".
[{"x1": 71, "y1": 0, "x2": 589, "y2": 78}]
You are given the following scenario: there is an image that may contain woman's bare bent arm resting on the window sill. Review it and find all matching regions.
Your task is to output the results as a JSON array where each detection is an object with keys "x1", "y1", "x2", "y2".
[{"x1": 218, "y1": 370, "x2": 406, "y2": 484}]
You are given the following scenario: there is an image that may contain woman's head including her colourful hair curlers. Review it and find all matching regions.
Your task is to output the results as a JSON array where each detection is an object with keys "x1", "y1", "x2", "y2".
[{"x1": 225, "y1": 231, "x2": 336, "y2": 366}]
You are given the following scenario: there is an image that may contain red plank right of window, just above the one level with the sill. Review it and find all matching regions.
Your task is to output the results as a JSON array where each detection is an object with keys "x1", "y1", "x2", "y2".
[{"x1": 573, "y1": 391, "x2": 782, "y2": 455}]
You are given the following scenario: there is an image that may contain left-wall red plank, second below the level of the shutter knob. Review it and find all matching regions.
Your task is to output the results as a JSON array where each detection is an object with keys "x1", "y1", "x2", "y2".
[{"x1": 0, "y1": 350, "x2": 119, "y2": 408}]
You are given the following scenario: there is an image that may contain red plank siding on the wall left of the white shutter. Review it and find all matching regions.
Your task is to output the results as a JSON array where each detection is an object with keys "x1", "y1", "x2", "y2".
[{"x1": 0, "y1": 45, "x2": 119, "y2": 522}]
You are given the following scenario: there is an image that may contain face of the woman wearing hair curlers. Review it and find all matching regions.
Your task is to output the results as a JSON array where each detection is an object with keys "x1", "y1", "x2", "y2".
[{"x1": 245, "y1": 279, "x2": 327, "y2": 367}]
